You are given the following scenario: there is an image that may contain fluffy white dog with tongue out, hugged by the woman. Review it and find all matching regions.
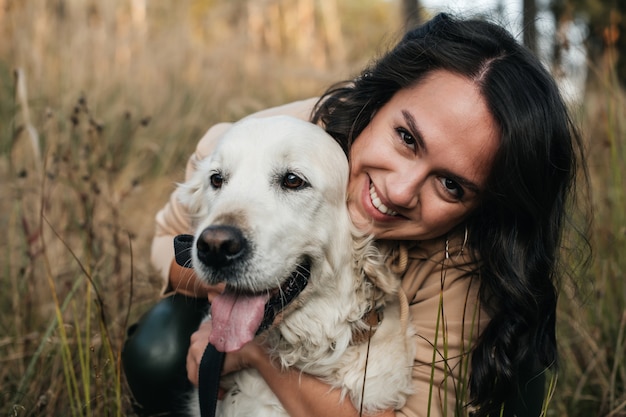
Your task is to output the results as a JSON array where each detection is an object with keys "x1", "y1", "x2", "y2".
[{"x1": 180, "y1": 116, "x2": 414, "y2": 417}]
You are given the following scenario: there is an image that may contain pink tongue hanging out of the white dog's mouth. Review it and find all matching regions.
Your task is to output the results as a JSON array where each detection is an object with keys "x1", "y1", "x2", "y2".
[{"x1": 209, "y1": 290, "x2": 269, "y2": 352}]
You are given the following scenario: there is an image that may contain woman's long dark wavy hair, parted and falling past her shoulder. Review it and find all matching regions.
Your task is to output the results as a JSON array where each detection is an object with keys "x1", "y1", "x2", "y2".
[{"x1": 312, "y1": 14, "x2": 588, "y2": 416}]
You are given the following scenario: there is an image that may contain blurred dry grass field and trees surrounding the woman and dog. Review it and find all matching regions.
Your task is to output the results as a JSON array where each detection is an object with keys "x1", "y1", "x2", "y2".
[{"x1": 0, "y1": 0, "x2": 626, "y2": 417}]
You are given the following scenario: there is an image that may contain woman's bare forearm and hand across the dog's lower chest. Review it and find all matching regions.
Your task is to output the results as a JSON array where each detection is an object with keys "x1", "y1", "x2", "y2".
[{"x1": 187, "y1": 321, "x2": 395, "y2": 417}]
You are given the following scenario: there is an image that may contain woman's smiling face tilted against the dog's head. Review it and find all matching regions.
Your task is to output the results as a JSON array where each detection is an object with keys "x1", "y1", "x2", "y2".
[{"x1": 348, "y1": 70, "x2": 498, "y2": 240}]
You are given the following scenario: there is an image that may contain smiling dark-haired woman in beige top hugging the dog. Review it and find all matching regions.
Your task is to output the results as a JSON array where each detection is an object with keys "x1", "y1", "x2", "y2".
[{"x1": 120, "y1": 15, "x2": 583, "y2": 416}]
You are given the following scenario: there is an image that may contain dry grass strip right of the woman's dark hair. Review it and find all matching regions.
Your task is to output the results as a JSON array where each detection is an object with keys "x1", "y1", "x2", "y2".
[{"x1": 552, "y1": 48, "x2": 626, "y2": 416}]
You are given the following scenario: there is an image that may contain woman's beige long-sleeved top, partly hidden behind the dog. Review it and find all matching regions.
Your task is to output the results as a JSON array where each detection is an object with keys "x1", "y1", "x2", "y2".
[{"x1": 152, "y1": 99, "x2": 489, "y2": 417}]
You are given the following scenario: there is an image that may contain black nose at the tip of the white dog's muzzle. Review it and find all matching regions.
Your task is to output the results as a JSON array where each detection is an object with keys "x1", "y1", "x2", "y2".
[{"x1": 196, "y1": 226, "x2": 247, "y2": 267}]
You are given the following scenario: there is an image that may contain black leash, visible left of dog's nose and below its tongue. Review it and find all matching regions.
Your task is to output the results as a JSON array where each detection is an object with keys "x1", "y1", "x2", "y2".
[{"x1": 174, "y1": 235, "x2": 225, "y2": 417}]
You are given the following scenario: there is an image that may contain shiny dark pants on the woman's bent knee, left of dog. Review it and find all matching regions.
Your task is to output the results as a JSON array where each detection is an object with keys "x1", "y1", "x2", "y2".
[{"x1": 122, "y1": 294, "x2": 209, "y2": 417}]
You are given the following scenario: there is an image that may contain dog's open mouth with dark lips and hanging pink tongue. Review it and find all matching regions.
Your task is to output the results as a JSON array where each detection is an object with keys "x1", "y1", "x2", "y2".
[{"x1": 209, "y1": 261, "x2": 311, "y2": 352}]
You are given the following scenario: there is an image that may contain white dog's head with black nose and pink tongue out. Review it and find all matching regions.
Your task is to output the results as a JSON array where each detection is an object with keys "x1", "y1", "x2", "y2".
[{"x1": 179, "y1": 116, "x2": 351, "y2": 350}]
